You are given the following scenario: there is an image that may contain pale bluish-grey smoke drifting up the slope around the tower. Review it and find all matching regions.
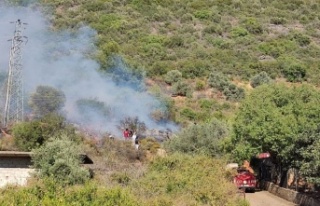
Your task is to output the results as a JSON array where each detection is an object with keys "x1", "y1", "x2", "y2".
[{"x1": 0, "y1": 3, "x2": 177, "y2": 136}]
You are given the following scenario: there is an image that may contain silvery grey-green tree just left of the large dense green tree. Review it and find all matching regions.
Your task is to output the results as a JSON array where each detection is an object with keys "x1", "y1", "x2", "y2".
[{"x1": 165, "y1": 119, "x2": 228, "y2": 156}]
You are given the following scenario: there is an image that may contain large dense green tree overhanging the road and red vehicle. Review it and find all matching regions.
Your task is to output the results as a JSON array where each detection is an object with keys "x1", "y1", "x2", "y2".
[{"x1": 230, "y1": 84, "x2": 320, "y2": 183}]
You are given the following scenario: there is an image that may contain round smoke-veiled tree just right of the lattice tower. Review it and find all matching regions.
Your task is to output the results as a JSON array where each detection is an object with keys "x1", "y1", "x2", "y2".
[{"x1": 29, "y1": 86, "x2": 66, "y2": 117}]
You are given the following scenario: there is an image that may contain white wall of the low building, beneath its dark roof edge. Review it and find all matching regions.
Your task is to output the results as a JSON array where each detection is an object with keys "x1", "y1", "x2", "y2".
[{"x1": 0, "y1": 157, "x2": 34, "y2": 187}]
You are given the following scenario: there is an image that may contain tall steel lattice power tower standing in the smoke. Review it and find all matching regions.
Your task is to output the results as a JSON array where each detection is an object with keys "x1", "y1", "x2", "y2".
[{"x1": 3, "y1": 19, "x2": 27, "y2": 126}]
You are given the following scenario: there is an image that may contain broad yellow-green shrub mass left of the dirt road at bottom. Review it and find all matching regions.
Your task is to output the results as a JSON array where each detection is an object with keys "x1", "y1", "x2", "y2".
[{"x1": 132, "y1": 153, "x2": 248, "y2": 206}]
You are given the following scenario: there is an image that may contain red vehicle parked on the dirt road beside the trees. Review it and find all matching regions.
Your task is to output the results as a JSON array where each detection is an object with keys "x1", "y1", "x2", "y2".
[{"x1": 233, "y1": 168, "x2": 257, "y2": 192}]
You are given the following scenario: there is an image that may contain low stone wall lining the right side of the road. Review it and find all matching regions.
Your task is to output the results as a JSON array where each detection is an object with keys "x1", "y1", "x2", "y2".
[{"x1": 263, "y1": 182, "x2": 320, "y2": 206}]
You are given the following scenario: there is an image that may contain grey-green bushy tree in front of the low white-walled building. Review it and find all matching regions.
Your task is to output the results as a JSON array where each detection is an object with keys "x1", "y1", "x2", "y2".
[{"x1": 32, "y1": 135, "x2": 90, "y2": 185}]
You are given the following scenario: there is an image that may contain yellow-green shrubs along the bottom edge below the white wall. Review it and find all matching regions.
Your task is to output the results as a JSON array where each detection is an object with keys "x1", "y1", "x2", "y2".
[{"x1": 0, "y1": 179, "x2": 140, "y2": 206}]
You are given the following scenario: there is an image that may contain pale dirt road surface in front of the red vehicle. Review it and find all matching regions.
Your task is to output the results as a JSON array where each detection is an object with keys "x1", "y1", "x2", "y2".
[{"x1": 246, "y1": 191, "x2": 296, "y2": 206}]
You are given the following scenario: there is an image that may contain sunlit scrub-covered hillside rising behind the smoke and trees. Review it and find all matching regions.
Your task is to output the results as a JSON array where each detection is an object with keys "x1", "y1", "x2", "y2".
[{"x1": 29, "y1": 0, "x2": 320, "y2": 123}]
